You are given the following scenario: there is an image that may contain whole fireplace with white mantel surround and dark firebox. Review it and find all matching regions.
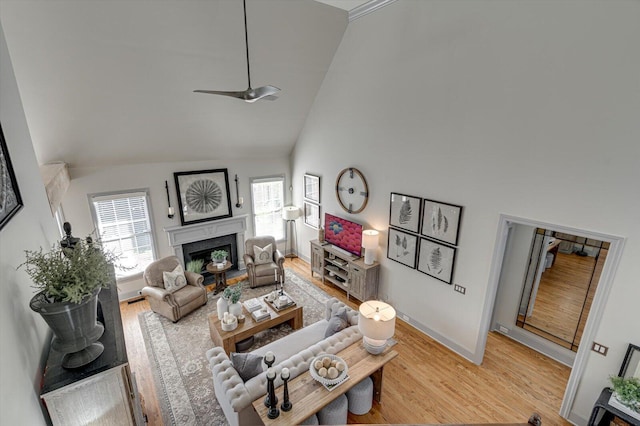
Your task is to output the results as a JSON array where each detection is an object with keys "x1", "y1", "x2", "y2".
[{"x1": 164, "y1": 215, "x2": 248, "y2": 284}]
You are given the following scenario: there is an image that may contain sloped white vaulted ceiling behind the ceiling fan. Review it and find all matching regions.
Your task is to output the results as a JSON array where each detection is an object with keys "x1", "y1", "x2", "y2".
[{"x1": 0, "y1": 0, "x2": 372, "y2": 166}]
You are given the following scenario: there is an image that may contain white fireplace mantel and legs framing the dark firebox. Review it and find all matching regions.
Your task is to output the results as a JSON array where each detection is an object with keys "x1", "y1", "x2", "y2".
[{"x1": 164, "y1": 214, "x2": 249, "y2": 271}]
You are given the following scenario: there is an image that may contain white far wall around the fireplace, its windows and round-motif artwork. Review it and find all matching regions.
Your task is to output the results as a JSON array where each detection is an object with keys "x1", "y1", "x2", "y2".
[{"x1": 62, "y1": 157, "x2": 290, "y2": 300}]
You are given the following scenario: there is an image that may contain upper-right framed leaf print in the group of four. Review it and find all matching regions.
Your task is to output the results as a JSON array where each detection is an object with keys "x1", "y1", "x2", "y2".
[{"x1": 421, "y1": 200, "x2": 462, "y2": 246}]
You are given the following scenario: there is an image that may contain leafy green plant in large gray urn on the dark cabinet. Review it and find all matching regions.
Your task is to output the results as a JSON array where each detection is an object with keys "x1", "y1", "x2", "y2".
[{"x1": 19, "y1": 238, "x2": 117, "y2": 368}]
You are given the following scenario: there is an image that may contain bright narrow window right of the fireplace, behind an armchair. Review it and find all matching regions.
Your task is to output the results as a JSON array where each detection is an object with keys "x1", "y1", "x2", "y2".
[{"x1": 251, "y1": 176, "x2": 284, "y2": 241}]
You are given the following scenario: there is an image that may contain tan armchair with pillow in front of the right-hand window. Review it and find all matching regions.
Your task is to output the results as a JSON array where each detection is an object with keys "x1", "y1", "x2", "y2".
[{"x1": 243, "y1": 236, "x2": 284, "y2": 288}]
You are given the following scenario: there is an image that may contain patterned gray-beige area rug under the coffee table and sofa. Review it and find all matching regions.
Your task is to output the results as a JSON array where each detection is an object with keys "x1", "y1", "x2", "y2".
[{"x1": 138, "y1": 269, "x2": 330, "y2": 426}]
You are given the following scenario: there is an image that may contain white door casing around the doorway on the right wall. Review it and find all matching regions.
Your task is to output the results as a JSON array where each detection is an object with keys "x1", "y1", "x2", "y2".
[{"x1": 480, "y1": 214, "x2": 626, "y2": 419}]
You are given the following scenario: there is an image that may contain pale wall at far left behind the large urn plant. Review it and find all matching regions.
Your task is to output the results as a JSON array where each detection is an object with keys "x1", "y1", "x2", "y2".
[{"x1": 0, "y1": 27, "x2": 59, "y2": 425}]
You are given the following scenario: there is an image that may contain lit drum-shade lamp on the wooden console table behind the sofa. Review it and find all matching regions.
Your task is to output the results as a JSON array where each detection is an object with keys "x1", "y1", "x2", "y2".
[{"x1": 358, "y1": 300, "x2": 396, "y2": 355}]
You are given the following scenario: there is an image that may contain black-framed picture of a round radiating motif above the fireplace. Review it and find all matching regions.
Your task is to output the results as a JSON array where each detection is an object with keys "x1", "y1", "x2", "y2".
[{"x1": 173, "y1": 169, "x2": 231, "y2": 225}]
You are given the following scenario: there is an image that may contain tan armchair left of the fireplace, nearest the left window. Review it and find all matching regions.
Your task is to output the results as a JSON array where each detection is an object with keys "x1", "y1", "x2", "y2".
[{"x1": 142, "y1": 256, "x2": 207, "y2": 322}]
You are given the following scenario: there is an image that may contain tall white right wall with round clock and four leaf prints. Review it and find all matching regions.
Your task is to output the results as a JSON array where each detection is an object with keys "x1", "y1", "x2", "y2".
[{"x1": 292, "y1": 0, "x2": 640, "y2": 419}]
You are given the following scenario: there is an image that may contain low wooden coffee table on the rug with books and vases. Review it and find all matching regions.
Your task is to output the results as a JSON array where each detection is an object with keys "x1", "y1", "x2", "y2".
[{"x1": 208, "y1": 303, "x2": 302, "y2": 355}]
